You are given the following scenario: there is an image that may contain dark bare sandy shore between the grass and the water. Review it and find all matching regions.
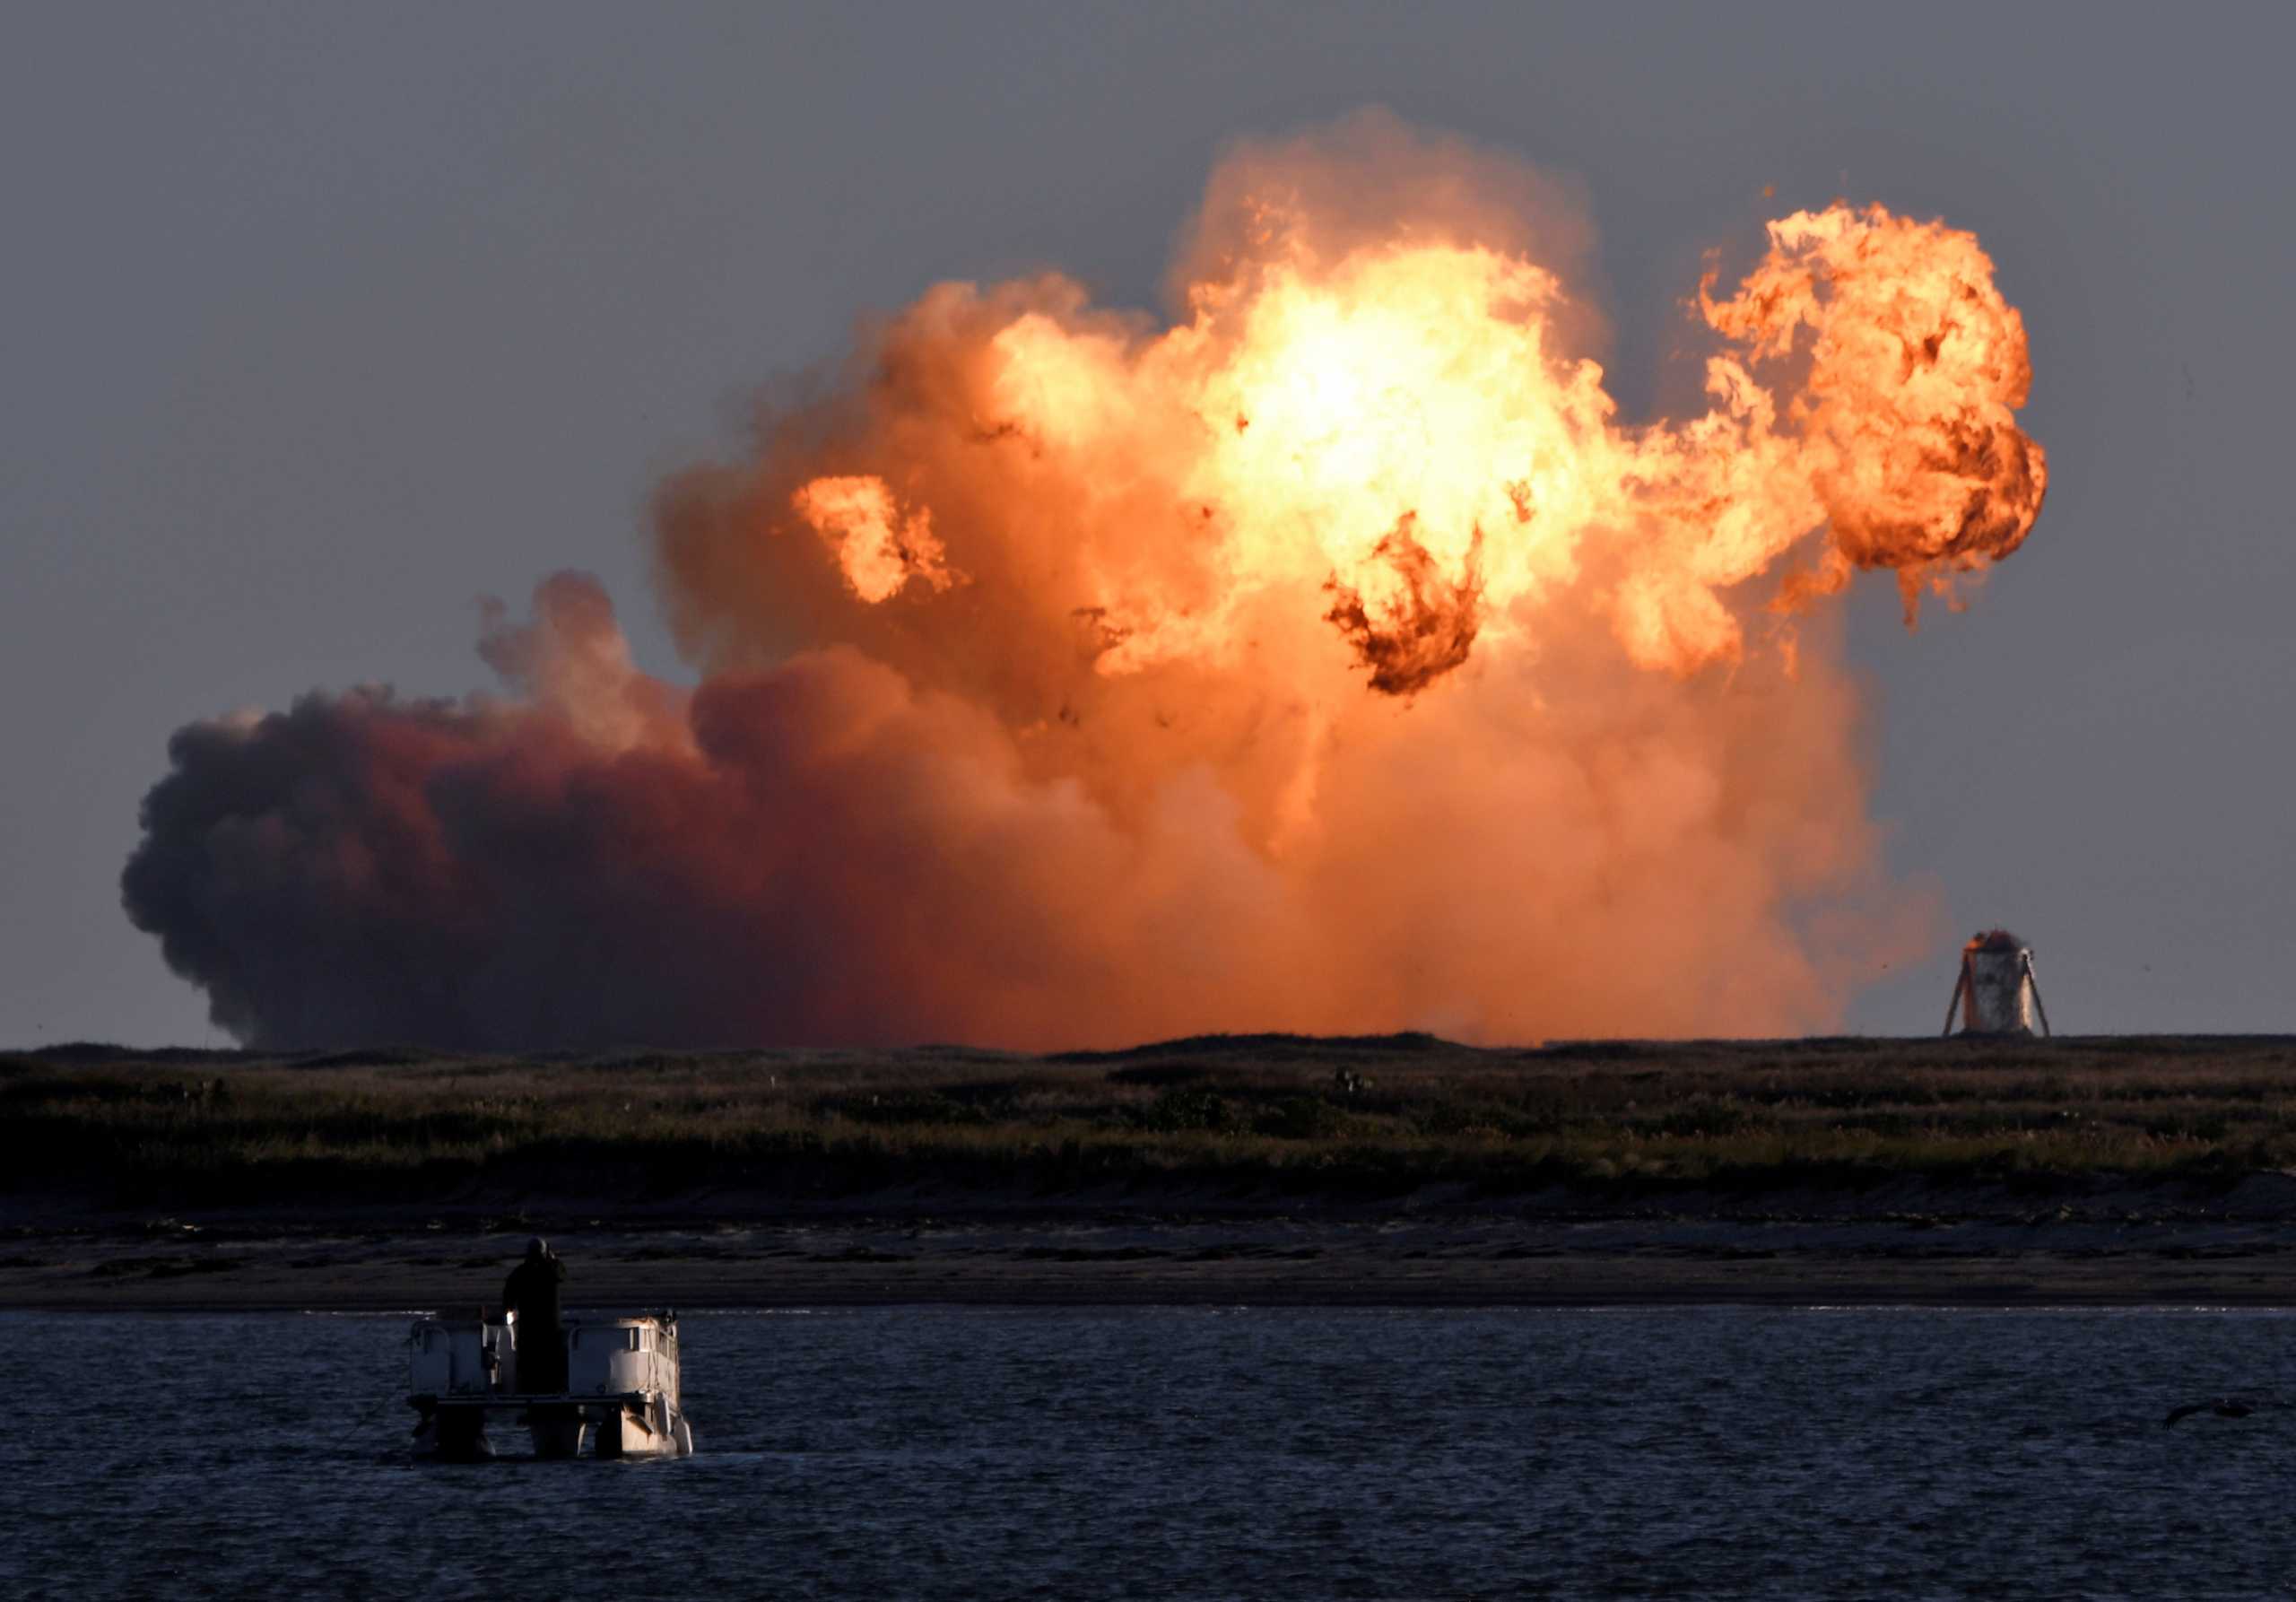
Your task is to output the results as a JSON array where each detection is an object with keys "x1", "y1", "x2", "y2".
[{"x1": 0, "y1": 1209, "x2": 2296, "y2": 1310}]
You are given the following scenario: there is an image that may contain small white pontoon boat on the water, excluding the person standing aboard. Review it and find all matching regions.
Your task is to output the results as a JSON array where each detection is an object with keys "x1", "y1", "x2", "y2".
[{"x1": 406, "y1": 1313, "x2": 693, "y2": 1462}]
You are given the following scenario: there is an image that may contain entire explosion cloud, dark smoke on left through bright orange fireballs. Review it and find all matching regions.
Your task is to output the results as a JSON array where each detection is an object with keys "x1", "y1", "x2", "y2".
[{"x1": 124, "y1": 117, "x2": 2046, "y2": 1049}]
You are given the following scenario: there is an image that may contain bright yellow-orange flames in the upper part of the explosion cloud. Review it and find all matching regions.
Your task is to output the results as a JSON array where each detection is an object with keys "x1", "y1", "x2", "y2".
[{"x1": 757, "y1": 186, "x2": 2048, "y2": 693}]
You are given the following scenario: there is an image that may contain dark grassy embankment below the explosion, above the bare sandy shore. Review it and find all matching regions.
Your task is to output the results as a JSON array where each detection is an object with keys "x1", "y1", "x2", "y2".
[{"x1": 0, "y1": 1035, "x2": 2296, "y2": 1205}]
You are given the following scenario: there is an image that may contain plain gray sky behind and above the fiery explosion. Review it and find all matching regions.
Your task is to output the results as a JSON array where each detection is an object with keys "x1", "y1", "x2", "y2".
[{"x1": 0, "y1": 4, "x2": 2296, "y2": 1044}]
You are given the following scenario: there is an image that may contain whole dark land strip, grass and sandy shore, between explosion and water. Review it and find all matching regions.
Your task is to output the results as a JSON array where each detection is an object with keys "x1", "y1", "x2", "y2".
[{"x1": 13, "y1": 1035, "x2": 2296, "y2": 1310}]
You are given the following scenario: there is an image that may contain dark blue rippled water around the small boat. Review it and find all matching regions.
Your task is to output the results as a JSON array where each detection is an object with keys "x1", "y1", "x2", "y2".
[{"x1": 0, "y1": 1308, "x2": 2296, "y2": 1598}]
